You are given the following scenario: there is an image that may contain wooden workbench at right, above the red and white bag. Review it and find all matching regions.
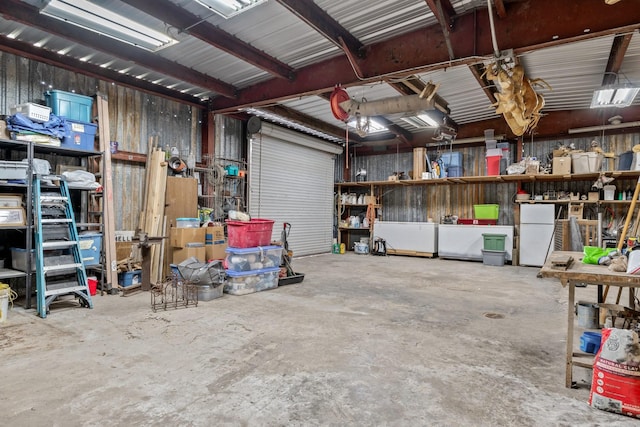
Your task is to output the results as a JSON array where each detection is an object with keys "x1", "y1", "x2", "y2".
[{"x1": 540, "y1": 251, "x2": 640, "y2": 387}]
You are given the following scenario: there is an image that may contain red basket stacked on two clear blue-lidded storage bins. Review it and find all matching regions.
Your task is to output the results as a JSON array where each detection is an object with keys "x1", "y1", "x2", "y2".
[{"x1": 224, "y1": 219, "x2": 282, "y2": 295}]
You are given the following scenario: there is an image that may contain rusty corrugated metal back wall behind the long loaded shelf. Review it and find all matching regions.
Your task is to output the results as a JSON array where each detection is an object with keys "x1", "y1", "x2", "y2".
[{"x1": 335, "y1": 133, "x2": 640, "y2": 225}]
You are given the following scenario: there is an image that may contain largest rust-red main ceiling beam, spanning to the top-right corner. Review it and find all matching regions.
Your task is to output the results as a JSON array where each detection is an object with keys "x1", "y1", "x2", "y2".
[{"x1": 212, "y1": 0, "x2": 640, "y2": 111}]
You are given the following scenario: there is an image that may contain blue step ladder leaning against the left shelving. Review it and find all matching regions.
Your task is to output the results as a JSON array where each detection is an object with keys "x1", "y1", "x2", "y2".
[{"x1": 33, "y1": 175, "x2": 93, "y2": 319}]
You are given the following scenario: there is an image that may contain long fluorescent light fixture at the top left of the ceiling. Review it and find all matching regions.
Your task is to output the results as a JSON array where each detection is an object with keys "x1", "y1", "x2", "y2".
[{"x1": 40, "y1": 0, "x2": 178, "y2": 51}]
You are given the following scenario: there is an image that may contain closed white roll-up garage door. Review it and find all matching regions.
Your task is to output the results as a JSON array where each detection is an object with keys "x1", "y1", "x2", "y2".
[{"x1": 248, "y1": 123, "x2": 342, "y2": 256}]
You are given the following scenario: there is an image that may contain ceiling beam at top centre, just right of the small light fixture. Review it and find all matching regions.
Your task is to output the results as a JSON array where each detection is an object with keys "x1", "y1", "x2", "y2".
[{"x1": 277, "y1": 0, "x2": 366, "y2": 58}]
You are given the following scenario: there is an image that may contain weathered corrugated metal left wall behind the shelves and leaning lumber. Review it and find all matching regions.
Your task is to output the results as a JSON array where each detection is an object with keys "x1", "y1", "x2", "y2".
[{"x1": 0, "y1": 52, "x2": 203, "y2": 230}]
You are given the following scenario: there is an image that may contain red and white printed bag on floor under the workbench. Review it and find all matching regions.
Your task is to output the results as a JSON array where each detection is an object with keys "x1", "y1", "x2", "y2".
[{"x1": 589, "y1": 328, "x2": 640, "y2": 418}]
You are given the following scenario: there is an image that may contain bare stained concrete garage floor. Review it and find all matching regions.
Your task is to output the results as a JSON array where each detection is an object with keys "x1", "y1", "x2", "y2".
[{"x1": 0, "y1": 253, "x2": 638, "y2": 426}]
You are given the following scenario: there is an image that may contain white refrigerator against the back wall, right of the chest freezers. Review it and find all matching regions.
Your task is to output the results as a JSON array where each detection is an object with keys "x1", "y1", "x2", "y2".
[{"x1": 520, "y1": 203, "x2": 555, "y2": 267}]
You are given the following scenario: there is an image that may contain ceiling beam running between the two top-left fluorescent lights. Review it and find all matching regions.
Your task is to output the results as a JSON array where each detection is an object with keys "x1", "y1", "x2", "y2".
[{"x1": 121, "y1": 0, "x2": 295, "y2": 80}]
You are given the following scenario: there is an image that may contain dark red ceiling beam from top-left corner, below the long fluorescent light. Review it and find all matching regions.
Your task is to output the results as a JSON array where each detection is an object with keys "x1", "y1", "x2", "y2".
[{"x1": 0, "y1": 0, "x2": 237, "y2": 98}]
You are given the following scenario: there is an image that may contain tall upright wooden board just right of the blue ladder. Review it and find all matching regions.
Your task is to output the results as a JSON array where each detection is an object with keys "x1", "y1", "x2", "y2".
[{"x1": 95, "y1": 93, "x2": 118, "y2": 287}]
